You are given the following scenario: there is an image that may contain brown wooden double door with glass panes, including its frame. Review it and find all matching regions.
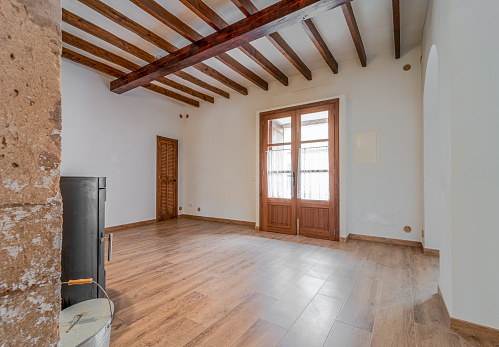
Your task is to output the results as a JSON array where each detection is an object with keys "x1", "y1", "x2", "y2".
[{"x1": 260, "y1": 99, "x2": 339, "y2": 240}]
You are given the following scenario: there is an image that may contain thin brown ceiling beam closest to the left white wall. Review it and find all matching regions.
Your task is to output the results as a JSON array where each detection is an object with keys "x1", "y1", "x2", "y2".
[{"x1": 62, "y1": 47, "x2": 199, "y2": 107}]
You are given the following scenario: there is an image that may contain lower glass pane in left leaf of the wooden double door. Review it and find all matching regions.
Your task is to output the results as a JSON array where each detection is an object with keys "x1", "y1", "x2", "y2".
[{"x1": 267, "y1": 146, "x2": 293, "y2": 199}]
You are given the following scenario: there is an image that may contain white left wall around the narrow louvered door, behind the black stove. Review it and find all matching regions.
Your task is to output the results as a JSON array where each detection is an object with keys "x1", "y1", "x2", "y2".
[{"x1": 61, "y1": 60, "x2": 184, "y2": 226}]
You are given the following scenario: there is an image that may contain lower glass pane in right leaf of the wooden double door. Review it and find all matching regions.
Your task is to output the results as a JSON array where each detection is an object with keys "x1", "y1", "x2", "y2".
[{"x1": 298, "y1": 146, "x2": 329, "y2": 200}]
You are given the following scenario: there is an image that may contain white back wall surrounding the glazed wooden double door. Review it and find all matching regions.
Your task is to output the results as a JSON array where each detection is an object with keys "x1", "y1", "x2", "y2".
[{"x1": 184, "y1": 47, "x2": 423, "y2": 241}]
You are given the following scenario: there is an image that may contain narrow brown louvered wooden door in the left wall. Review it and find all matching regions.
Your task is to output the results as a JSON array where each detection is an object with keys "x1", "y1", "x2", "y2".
[{"x1": 156, "y1": 136, "x2": 178, "y2": 220}]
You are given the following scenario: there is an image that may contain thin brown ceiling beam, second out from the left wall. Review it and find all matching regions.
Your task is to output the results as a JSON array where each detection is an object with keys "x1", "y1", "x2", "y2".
[{"x1": 62, "y1": 30, "x2": 215, "y2": 104}]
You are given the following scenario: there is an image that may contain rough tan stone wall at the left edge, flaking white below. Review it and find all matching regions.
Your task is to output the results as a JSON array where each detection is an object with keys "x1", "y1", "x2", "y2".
[{"x1": 0, "y1": 0, "x2": 62, "y2": 346}]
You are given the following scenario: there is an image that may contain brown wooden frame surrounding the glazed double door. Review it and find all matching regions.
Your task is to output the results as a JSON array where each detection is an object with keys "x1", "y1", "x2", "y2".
[{"x1": 258, "y1": 98, "x2": 340, "y2": 241}]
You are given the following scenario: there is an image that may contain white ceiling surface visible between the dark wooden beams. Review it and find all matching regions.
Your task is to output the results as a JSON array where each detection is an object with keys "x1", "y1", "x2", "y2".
[{"x1": 62, "y1": 0, "x2": 427, "y2": 100}]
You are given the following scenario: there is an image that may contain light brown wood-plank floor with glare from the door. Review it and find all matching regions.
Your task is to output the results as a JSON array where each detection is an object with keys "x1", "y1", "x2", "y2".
[{"x1": 106, "y1": 219, "x2": 471, "y2": 347}]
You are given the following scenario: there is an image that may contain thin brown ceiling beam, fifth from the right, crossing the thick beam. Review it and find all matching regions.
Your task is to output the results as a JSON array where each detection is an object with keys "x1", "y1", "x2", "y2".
[{"x1": 180, "y1": 0, "x2": 289, "y2": 86}]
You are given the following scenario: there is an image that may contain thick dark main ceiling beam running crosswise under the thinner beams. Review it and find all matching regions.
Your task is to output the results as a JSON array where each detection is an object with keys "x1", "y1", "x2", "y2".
[{"x1": 111, "y1": 0, "x2": 350, "y2": 94}]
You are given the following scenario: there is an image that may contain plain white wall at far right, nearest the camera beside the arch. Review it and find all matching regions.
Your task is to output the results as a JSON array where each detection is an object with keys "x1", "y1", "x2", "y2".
[{"x1": 423, "y1": 0, "x2": 499, "y2": 328}]
